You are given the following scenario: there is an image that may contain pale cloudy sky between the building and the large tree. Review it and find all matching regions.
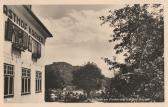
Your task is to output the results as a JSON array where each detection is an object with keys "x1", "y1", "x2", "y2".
[{"x1": 32, "y1": 5, "x2": 123, "y2": 77}]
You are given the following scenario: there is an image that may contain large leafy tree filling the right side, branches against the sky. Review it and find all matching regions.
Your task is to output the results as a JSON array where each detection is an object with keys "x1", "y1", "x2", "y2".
[{"x1": 100, "y1": 4, "x2": 164, "y2": 101}]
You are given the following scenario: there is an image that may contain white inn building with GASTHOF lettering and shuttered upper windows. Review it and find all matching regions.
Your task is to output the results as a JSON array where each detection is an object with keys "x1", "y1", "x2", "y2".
[{"x1": 3, "y1": 5, "x2": 52, "y2": 103}]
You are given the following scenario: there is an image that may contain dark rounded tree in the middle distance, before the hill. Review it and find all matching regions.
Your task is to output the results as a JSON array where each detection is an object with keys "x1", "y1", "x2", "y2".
[{"x1": 73, "y1": 62, "x2": 104, "y2": 97}]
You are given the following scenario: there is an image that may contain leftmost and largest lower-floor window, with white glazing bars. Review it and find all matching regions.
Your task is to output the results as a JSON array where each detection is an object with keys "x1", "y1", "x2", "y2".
[{"x1": 4, "y1": 63, "x2": 14, "y2": 98}]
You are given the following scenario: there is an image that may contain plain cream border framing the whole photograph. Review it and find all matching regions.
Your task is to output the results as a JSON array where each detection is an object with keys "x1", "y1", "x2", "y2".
[{"x1": 0, "y1": 0, "x2": 168, "y2": 107}]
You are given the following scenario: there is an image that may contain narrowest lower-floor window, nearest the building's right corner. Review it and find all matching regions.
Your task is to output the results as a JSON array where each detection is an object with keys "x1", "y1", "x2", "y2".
[{"x1": 36, "y1": 71, "x2": 42, "y2": 93}]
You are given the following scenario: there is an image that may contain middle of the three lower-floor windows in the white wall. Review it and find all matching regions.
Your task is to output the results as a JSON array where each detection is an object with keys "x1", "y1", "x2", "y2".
[{"x1": 21, "y1": 68, "x2": 31, "y2": 95}]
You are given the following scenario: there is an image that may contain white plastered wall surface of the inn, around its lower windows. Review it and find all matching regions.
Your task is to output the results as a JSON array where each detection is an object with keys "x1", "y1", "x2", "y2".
[{"x1": 3, "y1": 7, "x2": 45, "y2": 103}]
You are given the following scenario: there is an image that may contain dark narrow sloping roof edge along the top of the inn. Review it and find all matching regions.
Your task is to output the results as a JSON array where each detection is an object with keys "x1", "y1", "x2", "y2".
[{"x1": 23, "y1": 5, "x2": 53, "y2": 37}]
